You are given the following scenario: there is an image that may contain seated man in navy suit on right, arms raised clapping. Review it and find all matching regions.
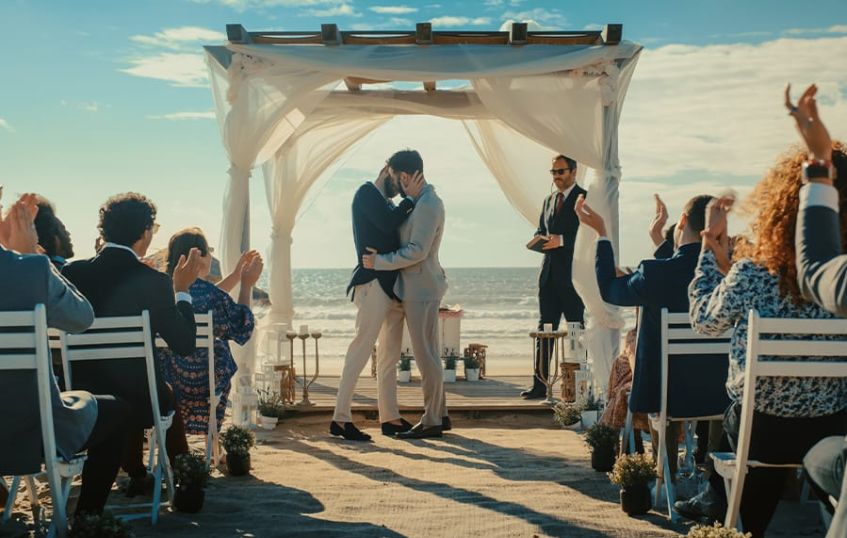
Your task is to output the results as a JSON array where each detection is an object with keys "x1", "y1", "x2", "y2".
[{"x1": 576, "y1": 195, "x2": 712, "y2": 474}]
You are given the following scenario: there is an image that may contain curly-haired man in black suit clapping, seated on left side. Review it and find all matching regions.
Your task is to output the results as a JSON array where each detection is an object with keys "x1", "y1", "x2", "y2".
[{"x1": 62, "y1": 193, "x2": 200, "y2": 496}]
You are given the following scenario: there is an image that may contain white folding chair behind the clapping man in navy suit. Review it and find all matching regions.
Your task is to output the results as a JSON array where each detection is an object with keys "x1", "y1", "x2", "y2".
[{"x1": 650, "y1": 308, "x2": 730, "y2": 521}]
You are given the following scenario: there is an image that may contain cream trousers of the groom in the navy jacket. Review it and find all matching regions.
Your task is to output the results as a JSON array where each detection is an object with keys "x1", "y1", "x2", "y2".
[{"x1": 332, "y1": 280, "x2": 404, "y2": 422}]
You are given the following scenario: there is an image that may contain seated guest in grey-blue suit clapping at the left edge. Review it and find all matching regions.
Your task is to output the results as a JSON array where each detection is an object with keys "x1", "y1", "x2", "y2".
[{"x1": 0, "y1": 195, "x2": 129, "y2": 514}]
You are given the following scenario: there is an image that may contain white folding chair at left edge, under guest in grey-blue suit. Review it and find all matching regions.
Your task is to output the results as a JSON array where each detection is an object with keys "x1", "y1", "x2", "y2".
[{"x1": 0, "y1": 304, "x2": 86, "y2": 536}]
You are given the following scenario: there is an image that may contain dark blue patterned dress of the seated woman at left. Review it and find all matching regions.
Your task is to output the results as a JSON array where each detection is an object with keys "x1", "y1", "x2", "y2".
[{"x1": 158, "y1": 279, "x2": 255, "y2": 435}]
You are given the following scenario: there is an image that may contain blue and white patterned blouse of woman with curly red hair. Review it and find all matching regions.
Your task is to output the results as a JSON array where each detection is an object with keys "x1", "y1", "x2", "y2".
[{"x1": 688, "y1": 251, "x2": 847, "y2": 417}]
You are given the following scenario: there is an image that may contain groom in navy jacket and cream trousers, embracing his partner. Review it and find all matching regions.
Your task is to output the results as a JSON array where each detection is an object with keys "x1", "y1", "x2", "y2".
[{"x1": 329, "y1": 165, "x2": 423, "y2": 441}]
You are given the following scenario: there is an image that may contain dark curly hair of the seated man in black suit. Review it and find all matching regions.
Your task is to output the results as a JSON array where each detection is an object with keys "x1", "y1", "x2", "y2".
[{"x1": 97, "y1": 192, "x2": 156, "y2": 247}]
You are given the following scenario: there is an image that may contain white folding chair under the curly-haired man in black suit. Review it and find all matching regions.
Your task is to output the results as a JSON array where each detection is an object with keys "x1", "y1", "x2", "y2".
[{"x1": 61, "y1": 310, "x2": 174, "y2": 525}]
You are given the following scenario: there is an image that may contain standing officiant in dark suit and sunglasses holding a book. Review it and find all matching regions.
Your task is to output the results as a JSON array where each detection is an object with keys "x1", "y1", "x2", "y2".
[{"x1": 521, "y1": 155, "x2": 585, "y2": 399}]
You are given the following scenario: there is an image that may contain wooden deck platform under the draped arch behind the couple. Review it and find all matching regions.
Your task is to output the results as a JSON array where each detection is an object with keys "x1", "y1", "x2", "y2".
[{"x1": 293, "y1": 376, "x2": 559, "y2": 413}]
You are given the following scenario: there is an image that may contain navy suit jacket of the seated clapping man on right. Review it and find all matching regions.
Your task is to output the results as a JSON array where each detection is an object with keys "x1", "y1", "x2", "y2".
[{"x1": 595, "y1": 241, "x2": 704, "y2": 413}]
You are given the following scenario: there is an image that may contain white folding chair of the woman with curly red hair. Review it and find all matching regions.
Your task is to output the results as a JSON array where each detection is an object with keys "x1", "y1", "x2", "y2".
[{"x1": 712, "y1": 310, "x2": 847, "y2": 528}]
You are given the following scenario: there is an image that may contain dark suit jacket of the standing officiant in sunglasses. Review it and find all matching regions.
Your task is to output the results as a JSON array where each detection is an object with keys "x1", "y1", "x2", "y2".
[{"x1": 535, "y1": 185, "x2": 585, "y2": 287}]
